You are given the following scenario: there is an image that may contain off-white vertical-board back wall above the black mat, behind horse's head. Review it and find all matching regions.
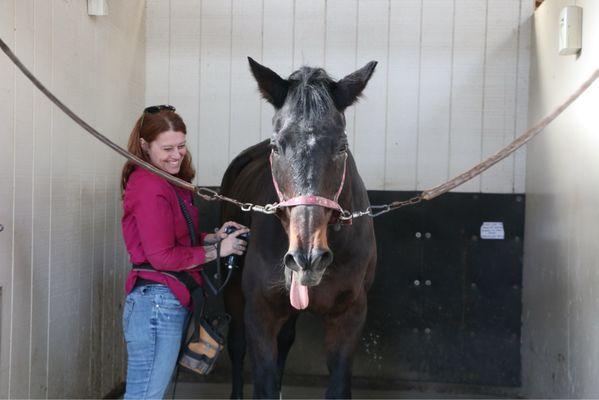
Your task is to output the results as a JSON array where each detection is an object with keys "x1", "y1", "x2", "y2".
[{"x1": 146, "y1": 0, "x2": 534, "y2": 193}]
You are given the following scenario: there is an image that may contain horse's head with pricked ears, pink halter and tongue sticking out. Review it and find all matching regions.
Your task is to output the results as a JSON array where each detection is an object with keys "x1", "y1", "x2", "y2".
[{"x1": 248, "y1": 58, "x2": 376, "y2": 309}]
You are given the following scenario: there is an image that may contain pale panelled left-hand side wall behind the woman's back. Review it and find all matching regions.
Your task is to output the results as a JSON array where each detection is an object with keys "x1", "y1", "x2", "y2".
[{"x1": 0, "y1": 0, "x2": 145, "y2": 398}]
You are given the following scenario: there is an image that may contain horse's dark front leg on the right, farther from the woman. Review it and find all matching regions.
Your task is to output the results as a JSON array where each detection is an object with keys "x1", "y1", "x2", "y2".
[{"x1": 324, "y1": 293, "x2": 367, "y2": 399}]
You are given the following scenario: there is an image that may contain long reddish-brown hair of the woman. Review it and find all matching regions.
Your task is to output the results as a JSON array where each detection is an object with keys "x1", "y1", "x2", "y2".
[{"x1": 121, "y1": 110, "x2": 195, "y2": 192}]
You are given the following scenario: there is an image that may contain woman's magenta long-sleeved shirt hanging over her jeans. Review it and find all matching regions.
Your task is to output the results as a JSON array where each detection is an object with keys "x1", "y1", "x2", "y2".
[{"x1": 121, "y1": 167, "x2": 206, "y2": 308}]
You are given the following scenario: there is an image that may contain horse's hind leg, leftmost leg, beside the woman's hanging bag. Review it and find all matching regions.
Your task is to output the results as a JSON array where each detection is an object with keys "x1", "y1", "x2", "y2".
[{"x1": 224, "y1": 271, "x2": 246, "y2": 399}]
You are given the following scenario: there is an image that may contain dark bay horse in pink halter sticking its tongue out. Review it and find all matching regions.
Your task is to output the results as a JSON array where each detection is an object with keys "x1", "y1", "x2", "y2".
[{"x1": 221, "y1": 58, "x2": 376, "y2": 398}]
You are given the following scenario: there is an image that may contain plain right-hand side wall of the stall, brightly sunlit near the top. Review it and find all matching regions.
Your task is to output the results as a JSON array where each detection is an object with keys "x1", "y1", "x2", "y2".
[{"x1": 522, "y1": 0, "x2": 599, "y2": 398}]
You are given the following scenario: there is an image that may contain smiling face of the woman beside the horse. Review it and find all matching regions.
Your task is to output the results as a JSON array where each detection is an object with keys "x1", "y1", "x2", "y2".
[{"x1": 141, "y1": 131, "x2": 187, "y2": 175}]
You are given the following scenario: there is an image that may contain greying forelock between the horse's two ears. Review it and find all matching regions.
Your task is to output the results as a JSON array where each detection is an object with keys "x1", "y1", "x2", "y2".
[{"x1": 286, "y1": 66, "x2": 336, "y2": 121}]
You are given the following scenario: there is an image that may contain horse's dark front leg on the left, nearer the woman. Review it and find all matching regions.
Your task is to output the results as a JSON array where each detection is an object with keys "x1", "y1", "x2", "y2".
[{"x1": 245, "y1": 296, "x2": 286, "y2": 399}]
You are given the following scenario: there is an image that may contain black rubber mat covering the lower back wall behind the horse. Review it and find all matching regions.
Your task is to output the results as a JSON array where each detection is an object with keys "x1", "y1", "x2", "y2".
[{"x1": 195, "y1": 191, "x2": 525, "y2": 387}]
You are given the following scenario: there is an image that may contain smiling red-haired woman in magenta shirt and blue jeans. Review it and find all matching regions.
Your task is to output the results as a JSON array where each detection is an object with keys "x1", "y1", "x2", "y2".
[{"x1": 121, "y1": 106, "x2": 248, "y2": 399}]
